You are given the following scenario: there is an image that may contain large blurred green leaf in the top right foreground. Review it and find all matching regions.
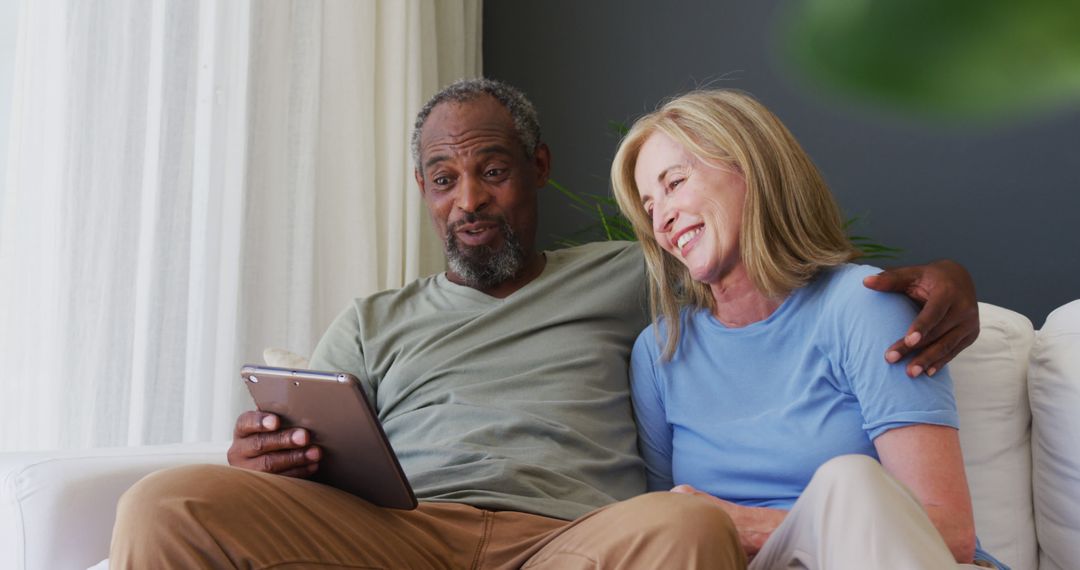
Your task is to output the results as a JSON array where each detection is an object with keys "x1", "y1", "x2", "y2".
[{"x1": 779, "y1": 0, "x2": 1080, "y2": 122}]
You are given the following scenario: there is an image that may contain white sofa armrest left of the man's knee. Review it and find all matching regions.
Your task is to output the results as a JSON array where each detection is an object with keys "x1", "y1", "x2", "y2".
[{"x1": 0, "y1": 443, "x2": 229, "y2": 569}]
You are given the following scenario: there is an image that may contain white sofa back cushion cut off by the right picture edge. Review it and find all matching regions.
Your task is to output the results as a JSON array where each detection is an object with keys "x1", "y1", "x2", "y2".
[{"x1": 1028, "y1": 300, "x2": 1080, "y2": 570}]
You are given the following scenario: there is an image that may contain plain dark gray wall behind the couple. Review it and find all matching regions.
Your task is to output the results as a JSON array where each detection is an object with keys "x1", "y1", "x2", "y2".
[{"x1": 484, "y1": 0, "x2": 1080, "y2": 327}]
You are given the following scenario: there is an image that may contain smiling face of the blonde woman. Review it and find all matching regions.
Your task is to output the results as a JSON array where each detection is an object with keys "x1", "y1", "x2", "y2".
[{"x1": 634, "y1": 132, "x2": 746, "y2": 284}]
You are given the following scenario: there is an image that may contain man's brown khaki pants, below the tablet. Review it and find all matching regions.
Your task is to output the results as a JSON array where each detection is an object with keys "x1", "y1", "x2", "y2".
[{"x1": 110, "y1": 465, "x2": 746, "y2": 570}]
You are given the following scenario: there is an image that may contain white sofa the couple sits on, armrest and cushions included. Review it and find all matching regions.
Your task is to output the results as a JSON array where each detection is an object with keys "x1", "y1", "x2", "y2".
[{"x1": 0, "y1": 300, "x2": 1080, "y2": 570}]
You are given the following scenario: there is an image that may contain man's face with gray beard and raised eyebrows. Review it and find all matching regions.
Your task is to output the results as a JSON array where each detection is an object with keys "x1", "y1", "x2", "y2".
[{"x1": 416, "y1": 96, "x2": 550, "y2": 288}]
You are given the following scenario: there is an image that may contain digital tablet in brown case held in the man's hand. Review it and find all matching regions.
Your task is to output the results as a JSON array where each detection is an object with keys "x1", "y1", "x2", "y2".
[{"x1": 240, "y1": 364, "x2": 417, "y2": 508}]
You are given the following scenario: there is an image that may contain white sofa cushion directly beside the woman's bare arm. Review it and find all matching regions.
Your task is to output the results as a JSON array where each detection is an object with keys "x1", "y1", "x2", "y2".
[{"x1": 949, "y1": 303, "x2": 1038, "y2": 568}]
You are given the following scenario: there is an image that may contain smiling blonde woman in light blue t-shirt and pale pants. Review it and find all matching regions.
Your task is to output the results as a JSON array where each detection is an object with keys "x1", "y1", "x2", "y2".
[{"x1": 611, "y1": 90, "x2": 1000, "y2": 569}]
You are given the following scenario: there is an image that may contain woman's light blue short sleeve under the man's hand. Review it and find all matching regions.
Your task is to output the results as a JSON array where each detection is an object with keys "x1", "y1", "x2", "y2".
[{"x1": 831, "y1": 266, "x2": 959, "y2": 439}]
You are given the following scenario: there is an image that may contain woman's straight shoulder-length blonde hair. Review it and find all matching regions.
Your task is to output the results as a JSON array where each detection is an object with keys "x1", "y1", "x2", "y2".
[{"x1": 611, "y1": 90, "x2": 859, "y2": 359}]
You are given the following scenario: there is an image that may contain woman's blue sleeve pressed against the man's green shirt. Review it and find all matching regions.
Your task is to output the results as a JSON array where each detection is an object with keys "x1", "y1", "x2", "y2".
[{"x1": 630, "y1": 325, "x2": 674, "y2": 491}]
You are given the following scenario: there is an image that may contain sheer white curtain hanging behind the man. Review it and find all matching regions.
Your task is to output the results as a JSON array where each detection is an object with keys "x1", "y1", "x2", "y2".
[{"x1": 0, "y1": 0, "x2": 481, "y2": 450}]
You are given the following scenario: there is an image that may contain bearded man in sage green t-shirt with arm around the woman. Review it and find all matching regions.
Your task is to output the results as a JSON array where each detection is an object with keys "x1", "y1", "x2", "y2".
[{"x1": 111, "y1": 79, "x2": 977, "y2": 569}]
